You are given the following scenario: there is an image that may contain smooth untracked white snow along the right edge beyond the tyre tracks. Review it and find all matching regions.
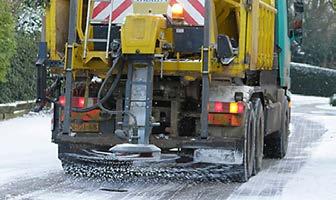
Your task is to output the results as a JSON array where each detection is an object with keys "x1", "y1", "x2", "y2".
[{"x1": 282, "y1": 100, "x2": 336, "y2": 200}]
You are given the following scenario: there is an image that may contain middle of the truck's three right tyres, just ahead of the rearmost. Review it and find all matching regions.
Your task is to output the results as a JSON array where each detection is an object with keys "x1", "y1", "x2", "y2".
[{"x1": 253, "y1": 99, "x2": 265, "y2": 175}]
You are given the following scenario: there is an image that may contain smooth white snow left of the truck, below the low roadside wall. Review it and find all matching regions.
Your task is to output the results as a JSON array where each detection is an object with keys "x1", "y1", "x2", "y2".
[{"x1": 0, "y1": 114, "x2": 61, "y2": 185}]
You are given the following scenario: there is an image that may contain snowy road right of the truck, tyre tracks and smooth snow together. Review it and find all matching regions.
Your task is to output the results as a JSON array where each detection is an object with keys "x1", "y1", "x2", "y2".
[{"x1": 229, "y1": 95, "x2": 336, "y2": 200}]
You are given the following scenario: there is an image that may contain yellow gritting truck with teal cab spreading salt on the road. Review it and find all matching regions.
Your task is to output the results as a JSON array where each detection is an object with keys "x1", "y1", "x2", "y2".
[{"x1": 37, "y1": 0, "x2": 301, "y2": 181}]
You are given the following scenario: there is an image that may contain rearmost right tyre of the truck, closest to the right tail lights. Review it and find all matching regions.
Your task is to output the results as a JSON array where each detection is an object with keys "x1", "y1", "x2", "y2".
[{"x1": 239, "y1": 105, "x2": 255, "y2": 182}]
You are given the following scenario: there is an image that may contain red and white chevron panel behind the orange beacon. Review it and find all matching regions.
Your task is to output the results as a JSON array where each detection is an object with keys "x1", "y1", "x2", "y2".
[{"x1": 167, "y1": 0, "x2": 205, "y2": 26}]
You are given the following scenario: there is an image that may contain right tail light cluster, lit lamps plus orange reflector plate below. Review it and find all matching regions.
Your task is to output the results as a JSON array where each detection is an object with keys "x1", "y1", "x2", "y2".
[{"x1": 208, "y1": 102, "x2": 245, "y2": 126}]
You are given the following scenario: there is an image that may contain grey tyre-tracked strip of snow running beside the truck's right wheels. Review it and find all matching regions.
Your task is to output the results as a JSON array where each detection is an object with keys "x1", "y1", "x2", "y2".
[{"x1": 229, "y1": 114, "x2": 326, "y2": 200}]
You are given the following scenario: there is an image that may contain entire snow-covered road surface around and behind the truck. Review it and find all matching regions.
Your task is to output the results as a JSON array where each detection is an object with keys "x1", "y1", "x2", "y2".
[{"x1": 0, "y1": 95, "x2": 336, "y2": 200}]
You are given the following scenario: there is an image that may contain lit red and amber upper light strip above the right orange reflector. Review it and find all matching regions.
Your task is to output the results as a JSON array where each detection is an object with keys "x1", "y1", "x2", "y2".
[{"x1": 209, "y1": 102, "x2": 245, "y2": 114}]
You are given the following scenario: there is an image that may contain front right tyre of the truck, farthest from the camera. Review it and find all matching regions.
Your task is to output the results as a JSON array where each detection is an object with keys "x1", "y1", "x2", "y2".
[{"x1": 264, "y1": 100, "x2": 289, "y2": 159}]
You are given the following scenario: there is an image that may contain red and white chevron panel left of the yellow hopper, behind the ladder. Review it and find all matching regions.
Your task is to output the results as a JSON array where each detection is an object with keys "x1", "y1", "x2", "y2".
[{"x1": 92, "y1": 0, "x2": 133, "y2": 24}]
